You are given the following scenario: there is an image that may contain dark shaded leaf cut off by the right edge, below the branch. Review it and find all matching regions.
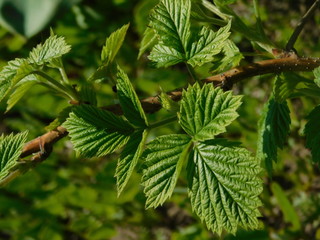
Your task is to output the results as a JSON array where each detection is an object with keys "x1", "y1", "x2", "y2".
[{"x1": 304, "y1": 106, "x2": 320, "y2": 164}]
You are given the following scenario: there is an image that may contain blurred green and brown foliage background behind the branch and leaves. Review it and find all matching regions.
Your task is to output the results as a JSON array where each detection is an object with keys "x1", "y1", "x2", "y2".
[{"x1": 0, "y1": 0, "x2": 320, "y2": 240}]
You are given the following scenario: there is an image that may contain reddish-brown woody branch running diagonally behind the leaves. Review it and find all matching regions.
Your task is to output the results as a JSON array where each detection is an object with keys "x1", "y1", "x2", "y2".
[{"x1": 20, "y1": 54, "x2": 320, "y2": 161}]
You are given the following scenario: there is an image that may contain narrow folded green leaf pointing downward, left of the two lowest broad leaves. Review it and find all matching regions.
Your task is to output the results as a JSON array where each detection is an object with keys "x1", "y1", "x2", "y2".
[{"x1": 115, "y1": 131, "x2": 148, "y2": 196}]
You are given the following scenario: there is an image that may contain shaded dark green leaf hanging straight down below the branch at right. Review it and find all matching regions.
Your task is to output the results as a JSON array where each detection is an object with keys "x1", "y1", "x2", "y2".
[{"x1": 257, "y1": 97, "x2": 291, "y2": 174}]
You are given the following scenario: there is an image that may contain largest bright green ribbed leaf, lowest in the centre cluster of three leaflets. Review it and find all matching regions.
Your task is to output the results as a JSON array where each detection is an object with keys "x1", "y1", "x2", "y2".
[{"x1": 188, "y1": 140, "x2": 262, "y2": 234}]
